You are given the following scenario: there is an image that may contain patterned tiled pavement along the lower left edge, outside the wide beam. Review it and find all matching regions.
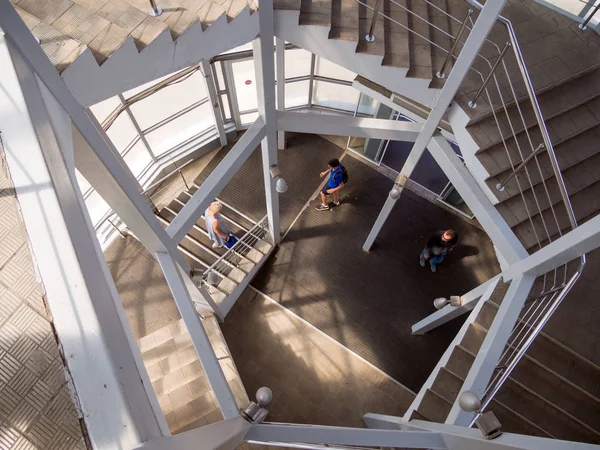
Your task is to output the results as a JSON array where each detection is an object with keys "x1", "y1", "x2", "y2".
[{"x1": 0, "y1": 157, "x2": 86, "y2": 450}]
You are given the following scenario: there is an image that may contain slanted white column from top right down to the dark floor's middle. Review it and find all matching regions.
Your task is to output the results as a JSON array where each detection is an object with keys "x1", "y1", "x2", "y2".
[{"x1": 363, "y1": 0, "x2": 506, "y2": 251}]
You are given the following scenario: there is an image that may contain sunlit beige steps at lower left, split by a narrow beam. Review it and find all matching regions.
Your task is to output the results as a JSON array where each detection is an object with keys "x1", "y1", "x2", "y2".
[{"x1": 138, "y1": 314, "x2": 249, "y2": 434}]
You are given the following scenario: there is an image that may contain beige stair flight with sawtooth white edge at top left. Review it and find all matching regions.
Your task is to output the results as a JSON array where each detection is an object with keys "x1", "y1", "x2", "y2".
[{"x1": 12, "y1": 0, "x2": 258, "y2": 106}]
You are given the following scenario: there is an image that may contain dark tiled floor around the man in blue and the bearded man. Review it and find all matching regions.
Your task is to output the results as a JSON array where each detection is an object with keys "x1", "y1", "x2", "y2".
[{"x1": 254, "y1": 151, "x2": 499, "y2": 390}]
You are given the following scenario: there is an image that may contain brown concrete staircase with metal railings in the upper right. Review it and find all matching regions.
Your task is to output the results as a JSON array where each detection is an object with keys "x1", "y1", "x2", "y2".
[{"x1": 275, "y1": 0, "x2": 600, "y2": 252}]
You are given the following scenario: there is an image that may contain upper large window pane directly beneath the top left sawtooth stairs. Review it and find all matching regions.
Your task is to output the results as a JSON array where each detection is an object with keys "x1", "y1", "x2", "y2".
[{"x1": 131, "y1": 71, "x2": 208, "y2": 130}]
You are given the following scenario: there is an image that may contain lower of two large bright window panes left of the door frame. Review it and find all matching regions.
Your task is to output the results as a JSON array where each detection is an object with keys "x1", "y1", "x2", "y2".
[{"x1": 146, "y1": 103, "x2": 215, "y2": 156}]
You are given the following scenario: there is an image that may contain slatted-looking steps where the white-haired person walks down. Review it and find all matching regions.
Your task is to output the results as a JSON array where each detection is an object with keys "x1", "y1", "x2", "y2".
[{"x1": 157, "y1": 178, "x2": 273, "y2": 319}]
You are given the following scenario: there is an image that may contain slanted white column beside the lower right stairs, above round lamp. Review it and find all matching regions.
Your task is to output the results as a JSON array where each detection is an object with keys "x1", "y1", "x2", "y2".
[{"x1": 446, "y1": 275, "x2": 536, "y2": 427}]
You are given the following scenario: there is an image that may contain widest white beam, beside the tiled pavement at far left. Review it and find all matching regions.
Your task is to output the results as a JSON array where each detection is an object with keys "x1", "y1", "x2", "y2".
[{"x1": 0, "y1": 34, "x2": 169, "y2": 449}]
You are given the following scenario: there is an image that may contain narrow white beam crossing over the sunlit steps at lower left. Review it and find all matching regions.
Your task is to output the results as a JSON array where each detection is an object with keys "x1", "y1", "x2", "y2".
[{"x1": 156, "y1": 253, "x2": 239, "y2": 419}]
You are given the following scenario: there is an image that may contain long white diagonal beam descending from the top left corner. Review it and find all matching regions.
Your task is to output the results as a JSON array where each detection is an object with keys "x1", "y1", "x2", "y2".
[{"x1": 0, "y1": 0, "x2": 188, "y2": 268}]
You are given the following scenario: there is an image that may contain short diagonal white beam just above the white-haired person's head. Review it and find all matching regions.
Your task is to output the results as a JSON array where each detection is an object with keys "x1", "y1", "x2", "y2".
[{"x1": 167, "y1": 117, "x2": 265, "y2": 242}]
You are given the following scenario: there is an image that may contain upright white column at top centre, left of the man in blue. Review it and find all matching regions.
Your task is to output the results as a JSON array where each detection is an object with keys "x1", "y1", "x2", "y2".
[{"x1": 252, "y1": 0, "x2": 285, "y2": 244}]
